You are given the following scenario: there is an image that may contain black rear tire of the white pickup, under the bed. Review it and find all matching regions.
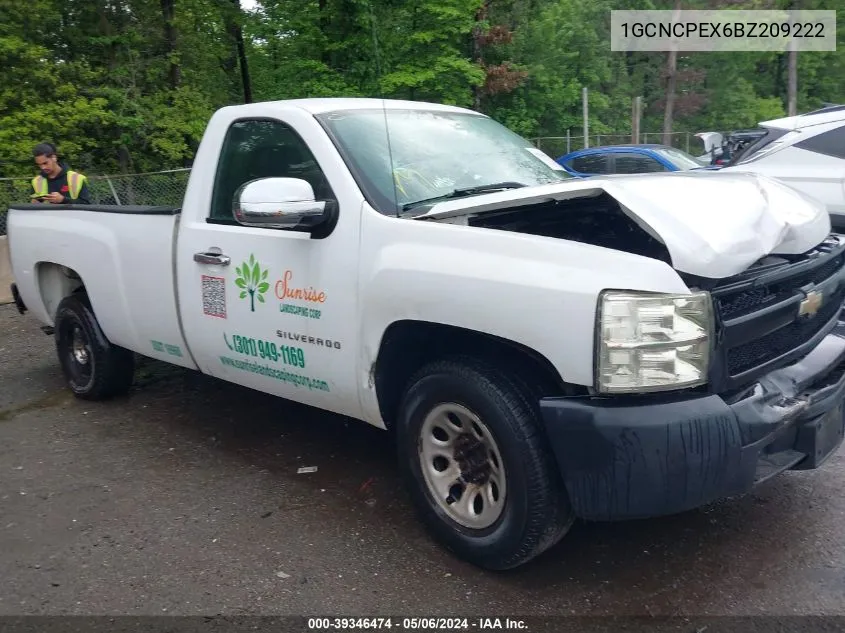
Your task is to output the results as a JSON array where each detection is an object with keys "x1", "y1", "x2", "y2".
[{"x1": 54, "y1": 293, "x2": 135, "y2": 400}]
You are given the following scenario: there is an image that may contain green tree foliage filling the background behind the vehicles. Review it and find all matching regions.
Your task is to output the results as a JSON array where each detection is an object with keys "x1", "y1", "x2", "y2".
[{"x1": 0, "y1": 0, "x2": 845, "y2": 176}]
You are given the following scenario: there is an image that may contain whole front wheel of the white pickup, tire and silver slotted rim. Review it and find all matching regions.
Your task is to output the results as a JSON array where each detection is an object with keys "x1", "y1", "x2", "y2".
[{"x1": 397, "y1": 359, "x2": 573, "y2": 570}]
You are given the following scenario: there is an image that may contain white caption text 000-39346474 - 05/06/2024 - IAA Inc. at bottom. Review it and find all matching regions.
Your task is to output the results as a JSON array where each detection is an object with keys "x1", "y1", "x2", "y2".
[{"x1": 308, "y1": 617, "x2": 528, "y2": 631}]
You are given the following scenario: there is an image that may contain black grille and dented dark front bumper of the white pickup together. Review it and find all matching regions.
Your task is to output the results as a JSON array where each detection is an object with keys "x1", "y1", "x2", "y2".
[{"x1": 540, "y1": 235, "x2": 845, "y2": 520}]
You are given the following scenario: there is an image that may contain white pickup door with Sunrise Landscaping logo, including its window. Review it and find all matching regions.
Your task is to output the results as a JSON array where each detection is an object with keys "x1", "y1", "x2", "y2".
[{"x1": 176, "y1": 111, "x2": 360, "y2": 414}]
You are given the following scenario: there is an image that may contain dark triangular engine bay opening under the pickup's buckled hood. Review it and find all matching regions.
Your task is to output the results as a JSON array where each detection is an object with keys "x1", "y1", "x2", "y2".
[{"x1": 468, "y1": 193, "x2": 672, "y2": 265}]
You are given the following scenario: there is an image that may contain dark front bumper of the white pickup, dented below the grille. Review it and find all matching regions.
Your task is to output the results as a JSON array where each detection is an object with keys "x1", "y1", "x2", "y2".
[{"x1": 540, "y1": 321, "x2": 845, "y2": 521}]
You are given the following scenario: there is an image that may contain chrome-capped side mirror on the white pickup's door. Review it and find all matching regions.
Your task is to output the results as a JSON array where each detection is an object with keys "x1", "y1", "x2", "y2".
[{"x1": 233, "y1": 178, "x2": 335, "y2": 232}]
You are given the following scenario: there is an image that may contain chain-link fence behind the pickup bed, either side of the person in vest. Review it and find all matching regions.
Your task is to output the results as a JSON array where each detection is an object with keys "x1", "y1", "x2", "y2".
[{"x1": 0, "y1": 169, "x2": 191, "y2": 235}]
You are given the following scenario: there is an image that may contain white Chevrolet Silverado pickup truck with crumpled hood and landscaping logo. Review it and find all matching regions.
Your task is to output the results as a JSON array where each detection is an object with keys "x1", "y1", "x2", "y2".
[{"x1": 4, "y1": 99, "x2": 845, "y2": 569}]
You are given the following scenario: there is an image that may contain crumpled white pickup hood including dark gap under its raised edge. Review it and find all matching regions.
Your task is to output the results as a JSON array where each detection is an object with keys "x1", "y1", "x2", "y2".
[{"x1": 418, "y1": 172, "x2": 830, "y2": 279}]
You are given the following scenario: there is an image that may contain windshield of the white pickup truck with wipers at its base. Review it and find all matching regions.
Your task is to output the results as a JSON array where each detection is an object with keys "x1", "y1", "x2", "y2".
[{"x1": 317, "y1": 108, "x2": 572, "y2": 215}]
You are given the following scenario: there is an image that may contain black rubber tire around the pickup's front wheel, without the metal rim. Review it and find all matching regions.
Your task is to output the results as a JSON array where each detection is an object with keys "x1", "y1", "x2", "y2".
[{"x1": 396, "y1": 358, "x2": 574, "y2": 570}]
